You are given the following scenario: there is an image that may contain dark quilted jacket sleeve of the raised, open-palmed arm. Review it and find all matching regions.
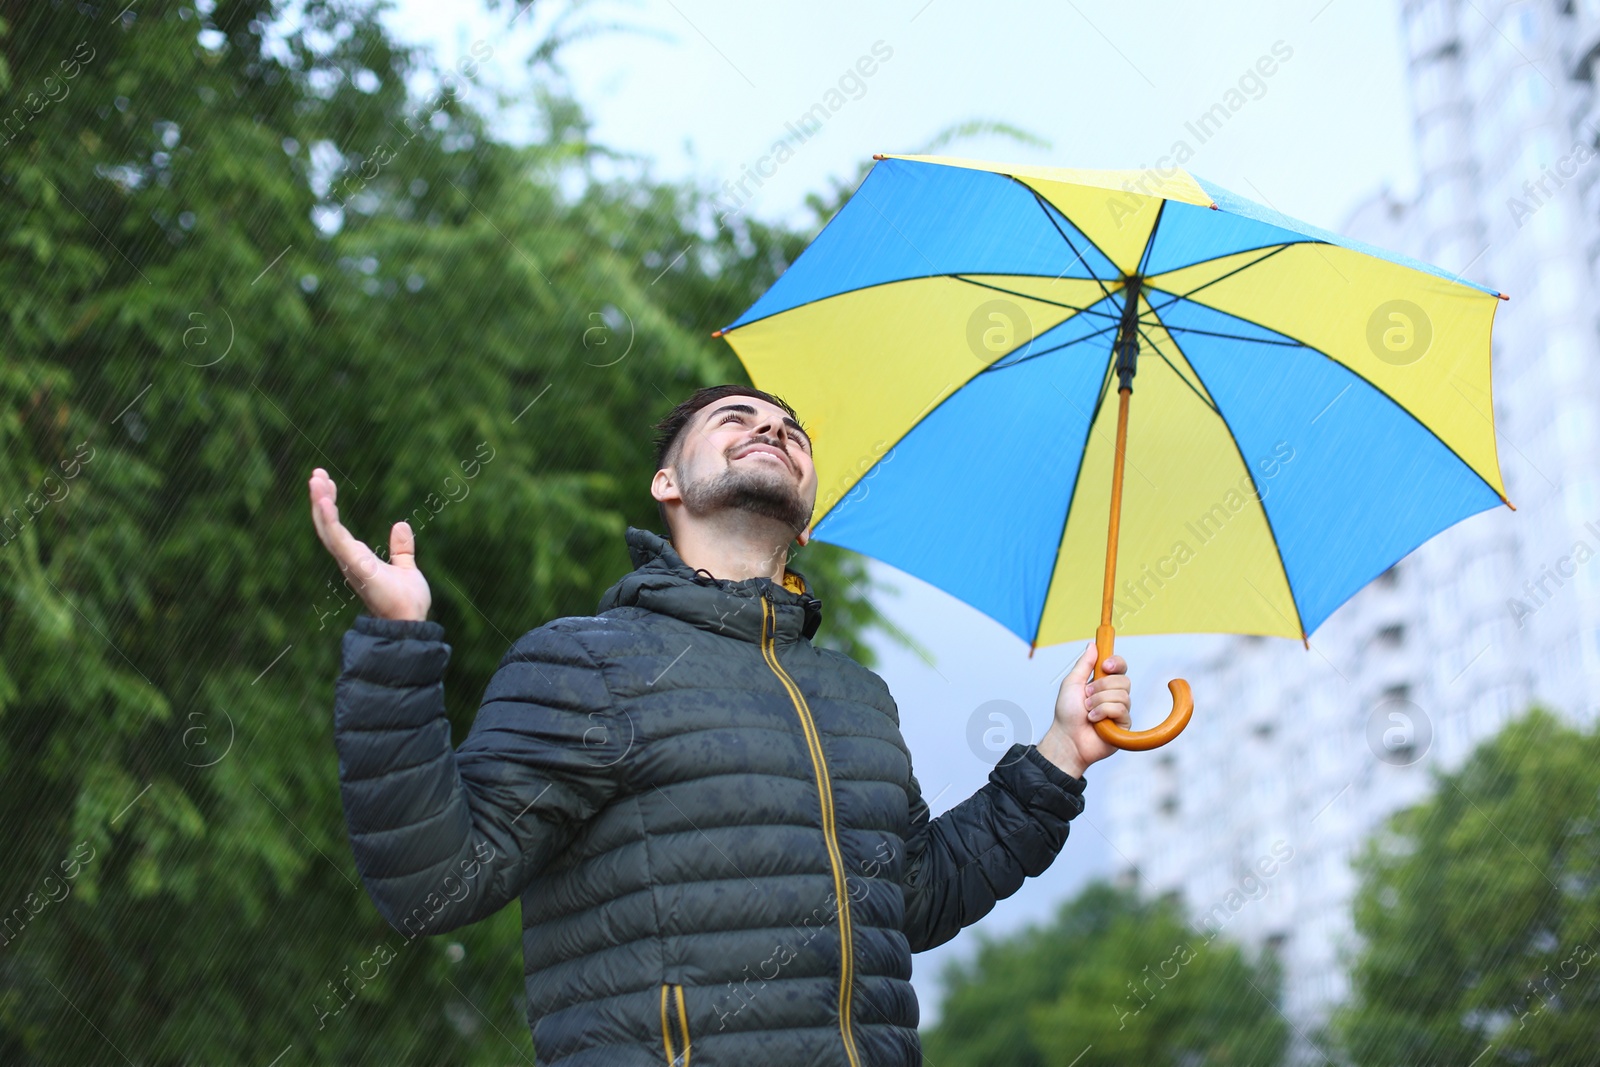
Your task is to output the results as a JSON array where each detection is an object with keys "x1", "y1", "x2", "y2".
[{"x1": 334, "y1": 614, "x2": 627, "y2": 937}]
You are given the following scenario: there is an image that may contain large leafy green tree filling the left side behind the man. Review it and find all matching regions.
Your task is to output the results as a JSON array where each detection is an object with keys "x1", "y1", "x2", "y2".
[{"x1": 0, "y1": 0, "x2": 896, "y2": 1064}]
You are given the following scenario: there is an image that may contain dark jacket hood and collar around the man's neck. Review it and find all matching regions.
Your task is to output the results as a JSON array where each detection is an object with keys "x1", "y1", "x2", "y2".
[{"x1": 597, "y1": 526, "x2": 822, "y2": 645}]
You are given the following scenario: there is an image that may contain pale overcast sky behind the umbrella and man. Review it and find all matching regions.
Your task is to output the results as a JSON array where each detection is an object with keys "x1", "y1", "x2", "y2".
[{"x1": 380, "y1": 0, "x2": 1416, "y2": 1019}]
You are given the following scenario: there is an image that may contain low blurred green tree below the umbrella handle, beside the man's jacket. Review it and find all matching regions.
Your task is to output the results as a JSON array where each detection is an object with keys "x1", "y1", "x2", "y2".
[{"x1": 923, "y1": 883, "x2": 1288, "y2": 1067}]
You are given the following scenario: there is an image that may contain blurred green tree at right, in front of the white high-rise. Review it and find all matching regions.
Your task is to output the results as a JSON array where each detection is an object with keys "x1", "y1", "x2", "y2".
[{"x1": 1333, "y1": 709, "x2": 1600, "y2": 1067}]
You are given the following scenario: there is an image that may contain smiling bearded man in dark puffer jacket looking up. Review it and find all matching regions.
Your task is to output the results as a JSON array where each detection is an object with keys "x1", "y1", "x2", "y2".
[{"x1": 310, "y1": 386, "x2": 1128, "y2": 1067}]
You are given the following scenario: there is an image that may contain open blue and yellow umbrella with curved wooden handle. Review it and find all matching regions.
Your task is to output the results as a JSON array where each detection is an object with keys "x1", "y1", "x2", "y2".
[{"x1": 718, "y1": 155, "x2": 1509, "y2": 749}]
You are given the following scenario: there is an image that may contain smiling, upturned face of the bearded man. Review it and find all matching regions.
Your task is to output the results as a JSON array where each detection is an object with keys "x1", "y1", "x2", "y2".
[{"x1": 651, "y1": 395, "x2": 816, "y2": 533}]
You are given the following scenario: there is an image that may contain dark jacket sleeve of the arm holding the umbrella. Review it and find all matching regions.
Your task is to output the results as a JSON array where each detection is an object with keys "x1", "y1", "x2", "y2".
[{"x1": 904, "y1": 744, "x2": 1086, "y2": 952}]
